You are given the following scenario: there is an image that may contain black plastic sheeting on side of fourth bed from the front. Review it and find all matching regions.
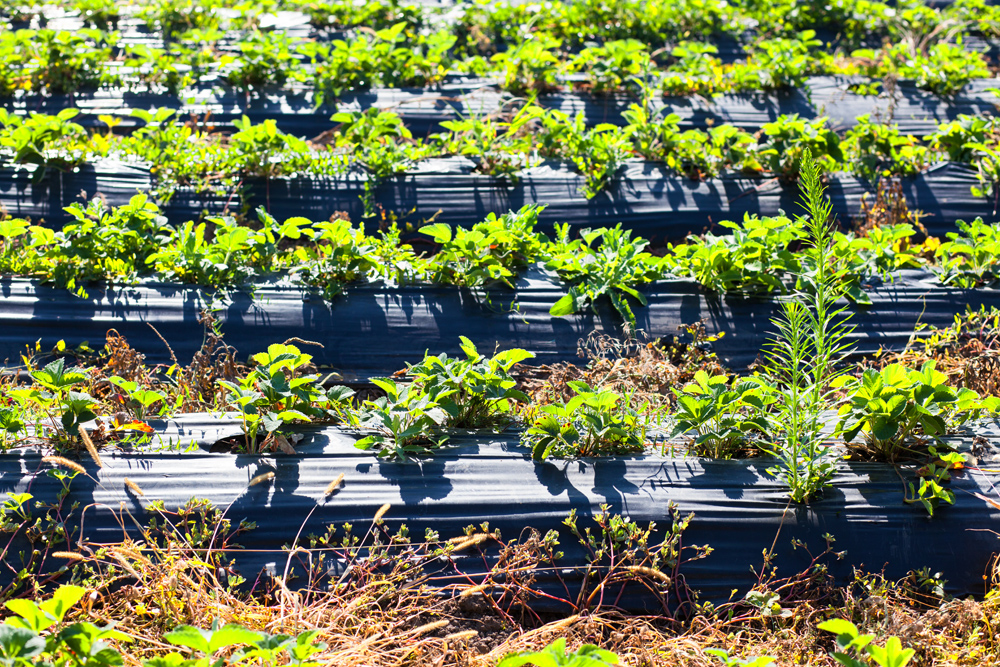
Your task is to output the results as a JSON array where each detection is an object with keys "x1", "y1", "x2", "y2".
[{"x1": 0, "y1": 76, "x2": 1000, "y2": 138}]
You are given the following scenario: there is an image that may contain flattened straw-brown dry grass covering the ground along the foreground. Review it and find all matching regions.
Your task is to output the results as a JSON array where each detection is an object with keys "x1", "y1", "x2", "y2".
[{"x1": 58, "y1": 544, "x2": 1000, "y2": 667}]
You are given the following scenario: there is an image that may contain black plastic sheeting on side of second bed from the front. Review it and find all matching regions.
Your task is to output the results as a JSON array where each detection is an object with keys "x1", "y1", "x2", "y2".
[{"x1": 0, "y1": 270, "x2": 1000, "y2": 381}]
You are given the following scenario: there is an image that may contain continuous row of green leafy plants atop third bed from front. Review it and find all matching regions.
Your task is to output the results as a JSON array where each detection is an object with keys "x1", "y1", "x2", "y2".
[{"x1": 9, "y1": 108, "x2": 1000, "y2": 204}]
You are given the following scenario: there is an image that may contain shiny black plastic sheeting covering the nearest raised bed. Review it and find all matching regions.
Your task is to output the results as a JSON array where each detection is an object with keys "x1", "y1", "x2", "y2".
[{"x1": 0, "y1": 428, "x2": 1000, "y2": 611}]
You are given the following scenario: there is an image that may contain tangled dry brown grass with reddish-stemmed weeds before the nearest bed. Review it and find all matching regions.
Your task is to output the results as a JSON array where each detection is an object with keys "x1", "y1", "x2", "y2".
[{"x1": 29, "y1": 498, "x2": 1000, "y2": 667}]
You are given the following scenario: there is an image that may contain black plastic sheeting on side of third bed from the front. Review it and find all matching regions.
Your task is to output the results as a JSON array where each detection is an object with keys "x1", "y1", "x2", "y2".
[{"x1": 164, "y1": 158, "x2": 1000, "y2": 242}]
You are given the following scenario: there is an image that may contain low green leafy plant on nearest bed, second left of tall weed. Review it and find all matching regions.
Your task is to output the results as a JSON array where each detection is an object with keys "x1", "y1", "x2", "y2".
[{"x1": 522, "y1": 380, "x2": 649, "y2": 461}]
